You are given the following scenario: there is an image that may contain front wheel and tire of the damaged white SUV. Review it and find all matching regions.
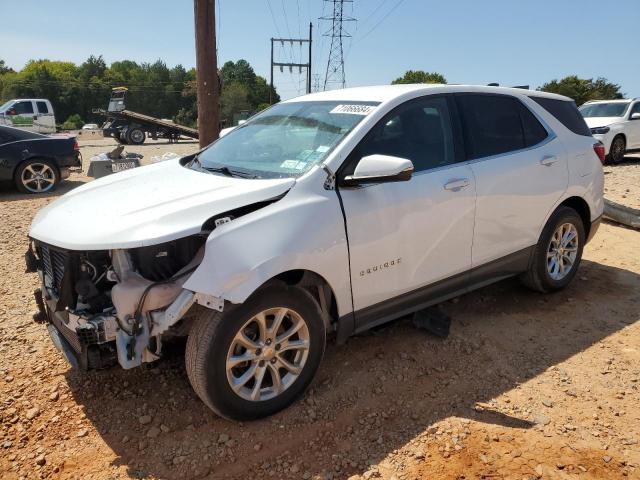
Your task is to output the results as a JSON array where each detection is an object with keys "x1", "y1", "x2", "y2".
[{"x1": 185, "y1": 285, "x2": 326, "y2": 420}]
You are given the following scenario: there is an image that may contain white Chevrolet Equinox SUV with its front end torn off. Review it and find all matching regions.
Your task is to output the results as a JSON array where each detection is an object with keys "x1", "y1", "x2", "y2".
[{"x1": 27, "y1": 85, "x2": 603, "y2": 419}]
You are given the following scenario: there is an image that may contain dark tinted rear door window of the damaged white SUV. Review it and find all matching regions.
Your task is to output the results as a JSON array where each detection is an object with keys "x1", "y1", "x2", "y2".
[{"x1": 457, "y1": 94, "x2": 526, "y2": 159}]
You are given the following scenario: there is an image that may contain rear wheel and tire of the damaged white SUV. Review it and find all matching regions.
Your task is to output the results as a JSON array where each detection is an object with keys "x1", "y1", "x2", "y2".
[{"x1": 521, "y1": 207, "x2": 586, "y2": 293}]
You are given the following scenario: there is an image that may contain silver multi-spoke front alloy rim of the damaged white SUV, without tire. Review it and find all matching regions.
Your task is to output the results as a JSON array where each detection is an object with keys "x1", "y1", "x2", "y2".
[{"x1": 226, "y1": 307, "x2": 310, "y2": 402}]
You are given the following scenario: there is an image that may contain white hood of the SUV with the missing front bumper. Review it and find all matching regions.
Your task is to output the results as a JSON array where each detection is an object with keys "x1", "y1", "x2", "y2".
[{"x1": 29, "y1": 159, "x2": 295, "y2": 250}]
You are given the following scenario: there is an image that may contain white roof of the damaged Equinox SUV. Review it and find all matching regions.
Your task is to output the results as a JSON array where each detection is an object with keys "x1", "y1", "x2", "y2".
[{"x1": 286, "y1": 83, "x2": 571, "y2": 102}]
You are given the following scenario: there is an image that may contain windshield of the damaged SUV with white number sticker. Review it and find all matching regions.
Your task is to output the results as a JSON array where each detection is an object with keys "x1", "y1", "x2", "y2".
[{"x1": 193, "y1": 102, "x2": 378, "y2": 178}]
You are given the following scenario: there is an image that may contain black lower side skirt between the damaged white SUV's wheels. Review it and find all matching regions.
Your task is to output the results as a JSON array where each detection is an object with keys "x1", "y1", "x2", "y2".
[{"x1": 339, "y1": 245, "x2": 535, "y2": 339}]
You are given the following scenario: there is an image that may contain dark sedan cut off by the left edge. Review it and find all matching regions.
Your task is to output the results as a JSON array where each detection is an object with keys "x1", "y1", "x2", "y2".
[{"x1": 0, "y1": 125, "x2": 82, "y2": 193}]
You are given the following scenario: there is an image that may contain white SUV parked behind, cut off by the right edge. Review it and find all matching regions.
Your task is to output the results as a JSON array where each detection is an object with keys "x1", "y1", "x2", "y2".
[{"x1": 580, "y1": 98, "x2": 640, "y2": 163}]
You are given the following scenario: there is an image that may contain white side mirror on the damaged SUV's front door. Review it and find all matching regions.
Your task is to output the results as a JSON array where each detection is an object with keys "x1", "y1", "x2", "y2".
[{"x1": 341, "y1": 154, "x2": 413, "y2": 187}]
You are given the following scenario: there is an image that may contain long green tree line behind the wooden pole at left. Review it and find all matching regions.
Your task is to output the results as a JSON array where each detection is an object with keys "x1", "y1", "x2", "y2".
[{"x1": 0, "y1": 55, "x2": 280, "y2": 128}]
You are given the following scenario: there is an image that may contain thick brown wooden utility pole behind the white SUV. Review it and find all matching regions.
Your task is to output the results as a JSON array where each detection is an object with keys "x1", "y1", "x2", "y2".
[{"x1": 193, "y1": 0, "x2": 220, "y2": 147}]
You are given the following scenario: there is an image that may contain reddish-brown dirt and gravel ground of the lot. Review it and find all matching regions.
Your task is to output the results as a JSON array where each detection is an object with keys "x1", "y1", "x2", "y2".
[{"x1": 0, "y1": 140, "x2": 640, "y2": 479}]
